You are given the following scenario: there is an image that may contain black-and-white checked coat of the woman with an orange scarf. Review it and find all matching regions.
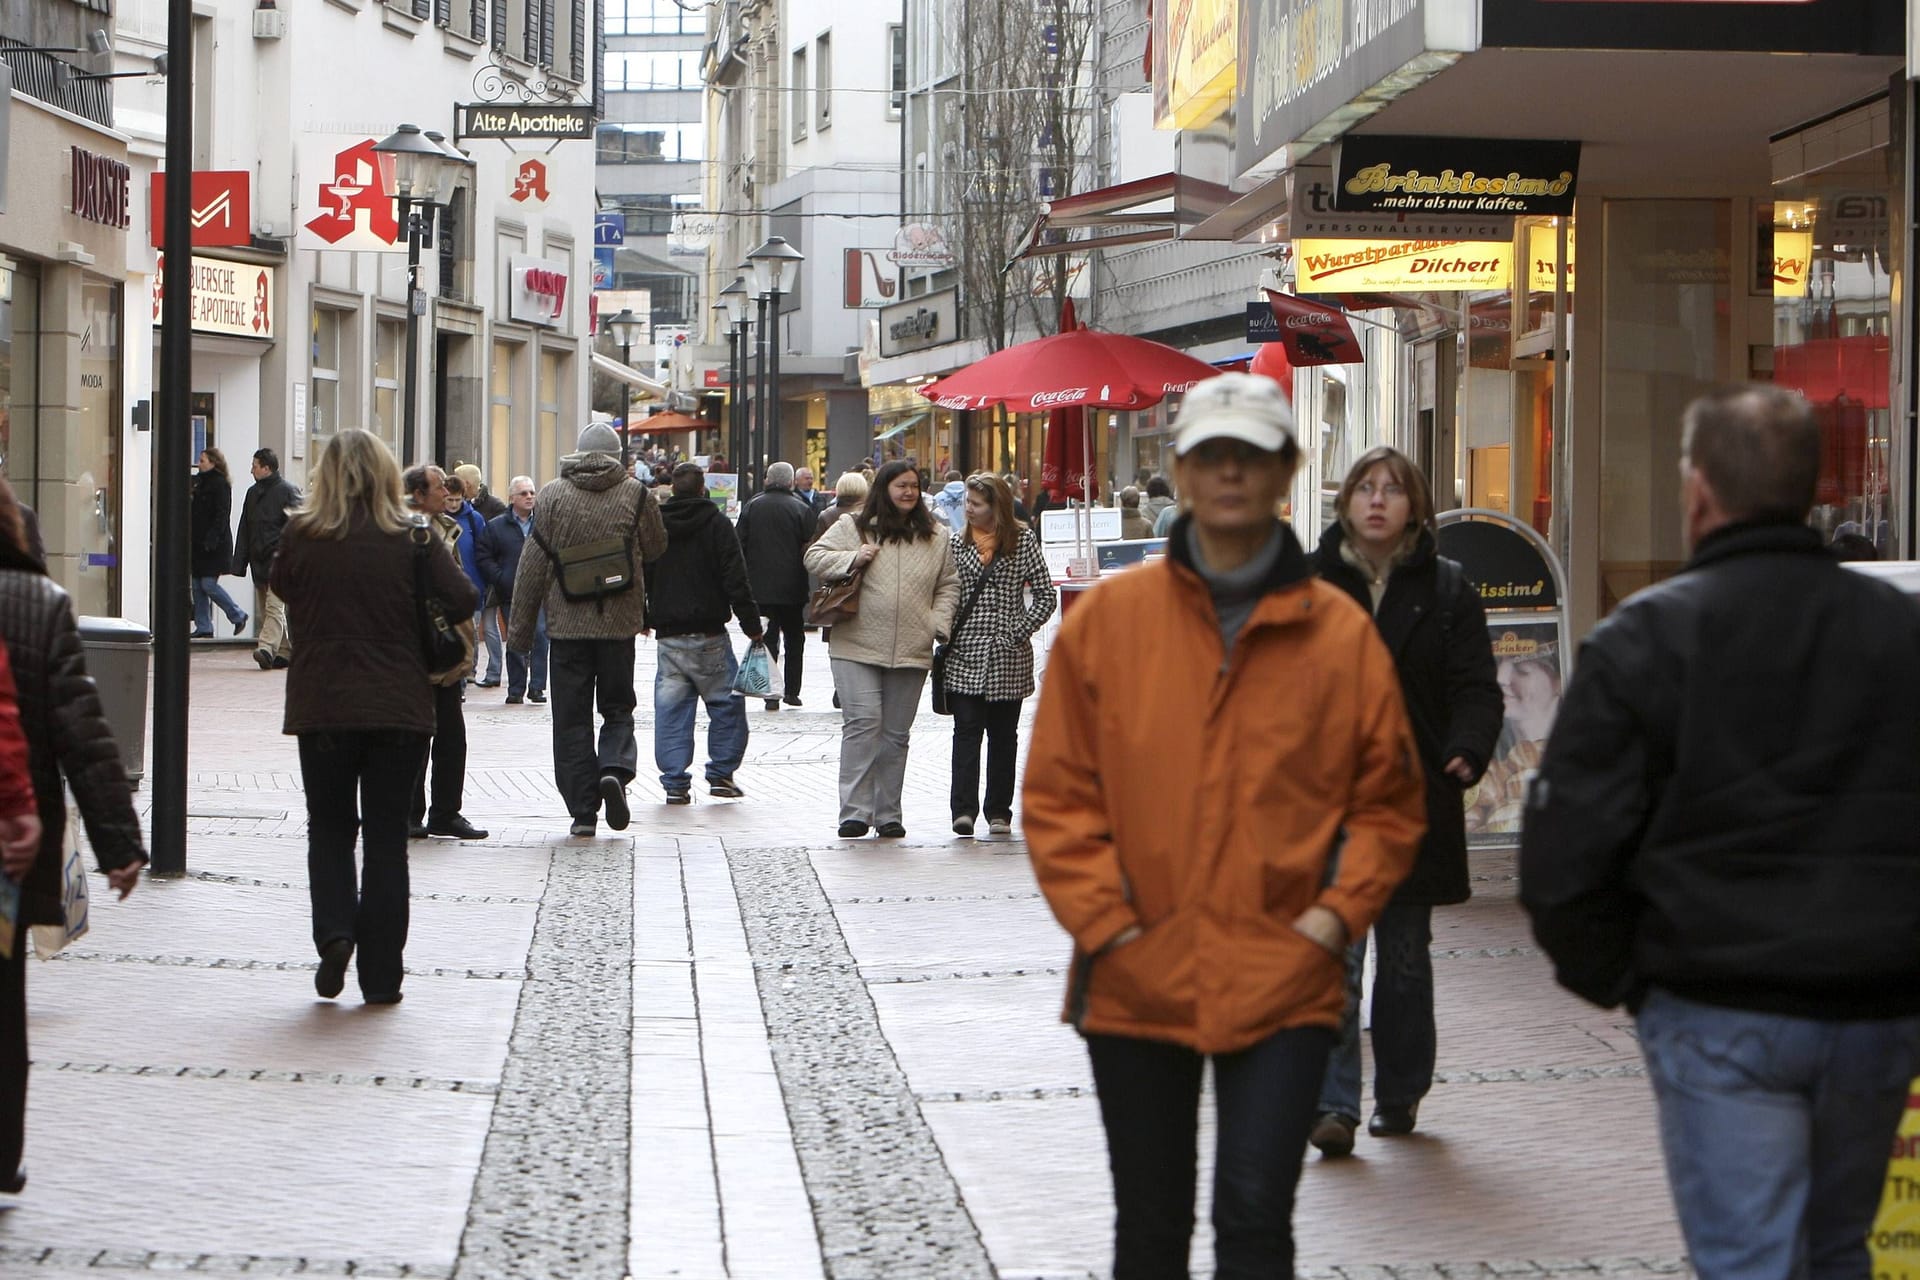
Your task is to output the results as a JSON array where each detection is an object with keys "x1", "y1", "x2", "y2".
[{"x1": 947, "y1": 528, "x2": 1060, "y2": 702}]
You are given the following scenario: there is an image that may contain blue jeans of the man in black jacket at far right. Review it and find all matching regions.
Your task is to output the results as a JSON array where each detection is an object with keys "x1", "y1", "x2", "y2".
[{"x1": 1640, "y1": 988, "x2": 1920, "y2": 1280}]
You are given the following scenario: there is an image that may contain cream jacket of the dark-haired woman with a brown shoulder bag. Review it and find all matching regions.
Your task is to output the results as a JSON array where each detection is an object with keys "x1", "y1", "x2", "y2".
[{"x1": 806, "y1": 514, "x2": 960, "y2": 670}]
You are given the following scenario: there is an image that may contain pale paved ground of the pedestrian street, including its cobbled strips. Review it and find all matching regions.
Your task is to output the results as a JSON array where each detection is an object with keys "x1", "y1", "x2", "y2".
[{"x1": 0, "y1": 629, "x2": 1686, "y2": 1280}]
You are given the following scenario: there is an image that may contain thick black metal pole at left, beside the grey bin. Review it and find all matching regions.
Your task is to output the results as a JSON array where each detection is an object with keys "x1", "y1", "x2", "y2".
[{"x1": 148, "y1": 0, "x2": 194, "y2": 875}]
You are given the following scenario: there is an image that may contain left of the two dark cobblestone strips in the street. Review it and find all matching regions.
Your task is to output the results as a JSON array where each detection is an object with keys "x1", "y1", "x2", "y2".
[{"x1": 453, "y1": 841, "x2": 634, "y2": 1280}]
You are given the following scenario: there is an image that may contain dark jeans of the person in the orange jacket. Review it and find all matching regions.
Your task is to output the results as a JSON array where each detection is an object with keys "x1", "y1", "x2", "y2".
[{"x1": 1087, "y1": 1027, "x2": 1332, "y2": 1280}]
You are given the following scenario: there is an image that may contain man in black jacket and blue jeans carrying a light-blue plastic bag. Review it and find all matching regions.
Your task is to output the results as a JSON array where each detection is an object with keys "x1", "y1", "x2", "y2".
[{"x1": 647, "y1": 462, "x2": 760, "y2": 804}]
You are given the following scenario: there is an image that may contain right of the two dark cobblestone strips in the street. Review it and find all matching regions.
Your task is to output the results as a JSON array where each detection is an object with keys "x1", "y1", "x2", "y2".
[{"x1": 728, "y1": 848, "x2": 995, "y2": 1280}]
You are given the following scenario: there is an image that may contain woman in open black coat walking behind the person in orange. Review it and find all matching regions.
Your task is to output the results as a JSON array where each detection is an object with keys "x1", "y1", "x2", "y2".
[{"x1": 1311, "y1": 447, "x2": 1501, "y2": 1157}]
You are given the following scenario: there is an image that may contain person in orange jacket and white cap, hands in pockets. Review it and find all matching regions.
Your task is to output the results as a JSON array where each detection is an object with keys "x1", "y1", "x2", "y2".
[{"x1": 1025, "y1": 374, "x2": 1427, "y2": 1280}]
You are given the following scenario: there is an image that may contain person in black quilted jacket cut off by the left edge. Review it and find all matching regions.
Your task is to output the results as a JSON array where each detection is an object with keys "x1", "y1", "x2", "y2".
[{"x1": 0, "y1": 480, "x2": 146, "y2": 1194}]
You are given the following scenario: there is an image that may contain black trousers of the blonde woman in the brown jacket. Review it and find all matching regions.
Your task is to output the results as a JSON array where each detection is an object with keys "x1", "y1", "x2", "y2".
[{"x1": 300, "y1": 729, "x2": 428, "y2": 996}]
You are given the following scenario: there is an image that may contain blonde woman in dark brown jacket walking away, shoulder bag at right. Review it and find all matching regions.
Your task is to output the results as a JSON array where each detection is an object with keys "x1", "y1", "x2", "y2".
[{"x1": 273, "y1": 428, "x2": 478, "y2": 1004}]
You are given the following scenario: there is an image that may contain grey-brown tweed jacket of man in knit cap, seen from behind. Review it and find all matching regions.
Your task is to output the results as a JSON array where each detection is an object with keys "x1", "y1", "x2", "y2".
[{"x1": 507, "y1": 453, "x2": 666, "y2": 652}]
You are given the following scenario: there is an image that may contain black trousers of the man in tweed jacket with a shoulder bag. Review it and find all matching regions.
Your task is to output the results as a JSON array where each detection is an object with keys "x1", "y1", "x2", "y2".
[{"x1": 547, "y1": 639, "x2": 639, "y2": 821}]
